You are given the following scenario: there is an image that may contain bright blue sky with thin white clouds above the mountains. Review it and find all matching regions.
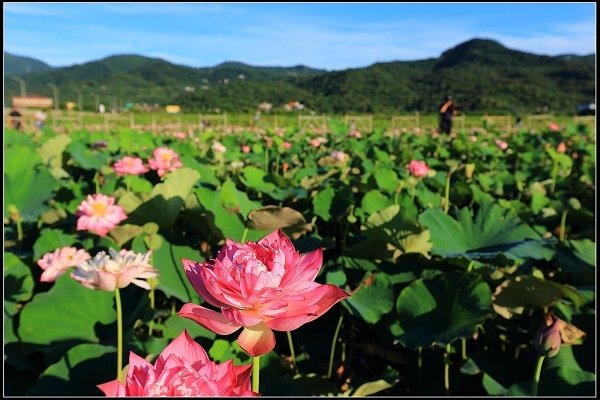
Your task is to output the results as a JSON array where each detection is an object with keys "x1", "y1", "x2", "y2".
[{"x1": 3, "y1": 2, "x2": 596, "y2": 70}]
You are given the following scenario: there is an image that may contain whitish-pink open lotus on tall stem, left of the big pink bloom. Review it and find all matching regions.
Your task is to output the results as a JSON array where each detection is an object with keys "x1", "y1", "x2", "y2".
[{"x1": 71, "y1": 249, "x2": 158, "y2": 291}]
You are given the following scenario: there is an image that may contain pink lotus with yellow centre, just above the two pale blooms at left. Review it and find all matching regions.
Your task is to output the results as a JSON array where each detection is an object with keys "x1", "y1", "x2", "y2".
[{"x1": 76, "y1": 193, "x2": 127, "y2": 236}]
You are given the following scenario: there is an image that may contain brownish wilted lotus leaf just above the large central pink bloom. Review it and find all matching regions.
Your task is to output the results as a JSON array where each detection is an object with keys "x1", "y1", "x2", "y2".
[{"x1": 248, "y1": 206, "x2": 312, "y2": 239}]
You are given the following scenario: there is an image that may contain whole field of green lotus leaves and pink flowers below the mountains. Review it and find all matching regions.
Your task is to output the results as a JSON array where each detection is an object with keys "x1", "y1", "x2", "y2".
[{"x1": 4, "y1": 119, "x2": 597, "y2": 397}]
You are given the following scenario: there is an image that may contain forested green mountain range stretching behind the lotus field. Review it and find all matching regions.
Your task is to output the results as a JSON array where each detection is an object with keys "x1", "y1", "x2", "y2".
[{"x1": 5, "y1": 39, "x2": 596, "y2": 114}]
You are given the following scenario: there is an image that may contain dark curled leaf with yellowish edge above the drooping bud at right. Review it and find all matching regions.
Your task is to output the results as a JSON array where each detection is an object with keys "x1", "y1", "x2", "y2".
[{"x1": 492, "y1": 276, "x2": 584, "y2": 319}]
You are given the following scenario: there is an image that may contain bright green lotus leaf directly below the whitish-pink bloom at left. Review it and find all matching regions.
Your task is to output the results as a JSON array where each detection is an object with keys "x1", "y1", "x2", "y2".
[{"x1": 19, "y1": 274, "x2": 116, "y2": 355}]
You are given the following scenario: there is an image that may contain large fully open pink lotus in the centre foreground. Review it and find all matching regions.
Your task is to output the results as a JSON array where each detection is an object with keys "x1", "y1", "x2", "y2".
[{"x1": 179, "y1": 230, "x2": 349, "y2": 356}]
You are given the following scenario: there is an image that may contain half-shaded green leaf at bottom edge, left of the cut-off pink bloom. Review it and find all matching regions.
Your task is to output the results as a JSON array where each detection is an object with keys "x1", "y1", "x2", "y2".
[{"x1": 27, "y1": 344, "x2": 116, "y2": 397}]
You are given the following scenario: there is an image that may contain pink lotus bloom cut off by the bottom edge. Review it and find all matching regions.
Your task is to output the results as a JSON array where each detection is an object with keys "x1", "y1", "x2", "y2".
[{"x1": 97, "y1": 330, "x2": 257, "y2": 397}]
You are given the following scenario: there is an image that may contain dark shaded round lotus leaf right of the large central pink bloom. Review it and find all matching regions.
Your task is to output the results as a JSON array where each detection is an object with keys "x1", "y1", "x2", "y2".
[{"x1": 394, "y1": 272, "x2": 492, "y2": 348}]
